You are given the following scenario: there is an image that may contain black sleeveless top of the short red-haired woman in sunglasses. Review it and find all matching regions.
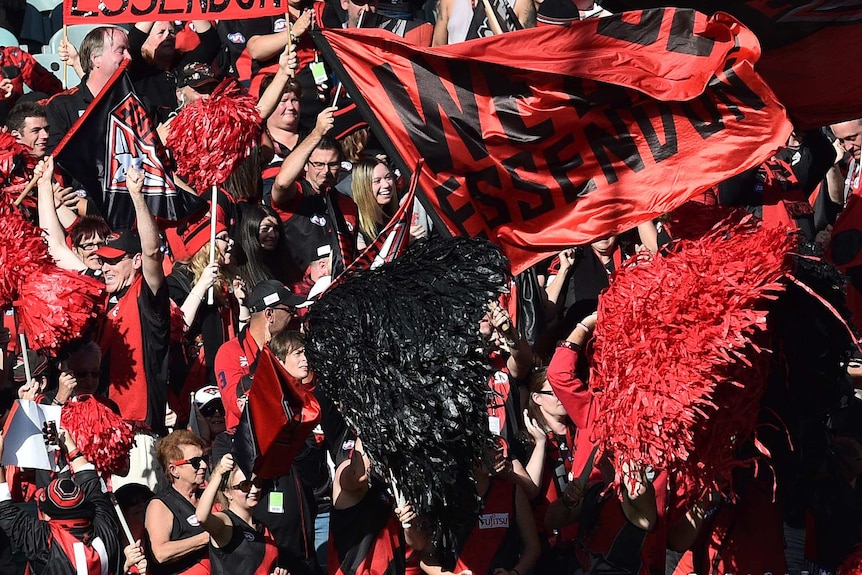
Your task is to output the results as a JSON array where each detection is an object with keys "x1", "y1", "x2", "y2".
[{"x1": 146, "y1": 487, "x2": 211, "y2": 575}]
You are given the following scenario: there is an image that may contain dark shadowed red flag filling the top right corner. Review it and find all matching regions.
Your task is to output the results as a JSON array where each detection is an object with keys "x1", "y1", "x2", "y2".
[{"x1": 602, "y1": 0, "x2": 862, "y2": 129}]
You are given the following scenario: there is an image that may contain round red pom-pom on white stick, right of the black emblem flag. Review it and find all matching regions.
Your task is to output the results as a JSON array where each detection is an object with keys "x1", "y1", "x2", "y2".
[{"x1": 167, "y1": 79, "x2": 261, "y2": 192}]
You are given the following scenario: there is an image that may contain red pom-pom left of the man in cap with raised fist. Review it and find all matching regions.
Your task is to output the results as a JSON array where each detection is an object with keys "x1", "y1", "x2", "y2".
[{"x1": 15, "y1": 265, "x2": 105, "y2": 351}]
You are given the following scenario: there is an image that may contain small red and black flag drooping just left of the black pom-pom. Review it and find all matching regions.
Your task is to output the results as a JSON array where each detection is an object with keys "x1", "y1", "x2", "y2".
[{"x1": 234, "y1": 347, "x2": 320, "y2": 479}]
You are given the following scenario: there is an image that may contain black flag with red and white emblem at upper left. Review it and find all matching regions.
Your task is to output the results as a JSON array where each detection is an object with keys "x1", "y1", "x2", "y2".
[{"x1": 54, "y1": 64, "x2": 206, "y2": 230}]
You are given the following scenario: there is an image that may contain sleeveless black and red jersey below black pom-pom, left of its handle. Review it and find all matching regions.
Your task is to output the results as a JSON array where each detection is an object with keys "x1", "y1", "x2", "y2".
[{"x1": 327, "y1": 484, "x2": 406, "y2": 575}]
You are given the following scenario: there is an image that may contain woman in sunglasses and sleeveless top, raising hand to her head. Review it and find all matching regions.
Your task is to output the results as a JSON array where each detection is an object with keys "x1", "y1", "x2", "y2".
[{"x1": 195, "y1": 453, "x2": 287, "y2": 575}]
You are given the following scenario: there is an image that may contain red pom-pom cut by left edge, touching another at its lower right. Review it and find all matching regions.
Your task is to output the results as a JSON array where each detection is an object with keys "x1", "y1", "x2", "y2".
[{"x1": 0, "y1": 204, "x2": 53, "y2": 307}]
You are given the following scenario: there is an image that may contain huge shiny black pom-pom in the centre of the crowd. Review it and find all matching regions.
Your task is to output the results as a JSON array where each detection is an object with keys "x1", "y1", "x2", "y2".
[{"x1": 306, "y1": 238, "x2": 509, "y2": 539}]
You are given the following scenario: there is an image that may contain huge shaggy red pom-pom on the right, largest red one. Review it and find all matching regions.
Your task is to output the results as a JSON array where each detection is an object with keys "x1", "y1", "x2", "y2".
[{"x1": 590, "y1": 210, "x2": 794, "y2": 504}]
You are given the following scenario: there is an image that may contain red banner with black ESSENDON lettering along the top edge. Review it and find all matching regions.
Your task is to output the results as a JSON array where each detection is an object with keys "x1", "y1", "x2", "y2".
[{"x1": 63, "y1": 0, "x2": 287, "y2": 26}]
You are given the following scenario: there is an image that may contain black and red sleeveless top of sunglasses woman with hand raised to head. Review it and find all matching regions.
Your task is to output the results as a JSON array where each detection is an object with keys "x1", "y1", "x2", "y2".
[{"x1": 209, "y1": 510, "x2": 278, "y2": 575}]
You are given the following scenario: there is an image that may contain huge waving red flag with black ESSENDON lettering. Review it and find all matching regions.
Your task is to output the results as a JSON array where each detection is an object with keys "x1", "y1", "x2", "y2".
[{"x1": 319, "y1": 8, "x2": 791, "y2": 275}]
